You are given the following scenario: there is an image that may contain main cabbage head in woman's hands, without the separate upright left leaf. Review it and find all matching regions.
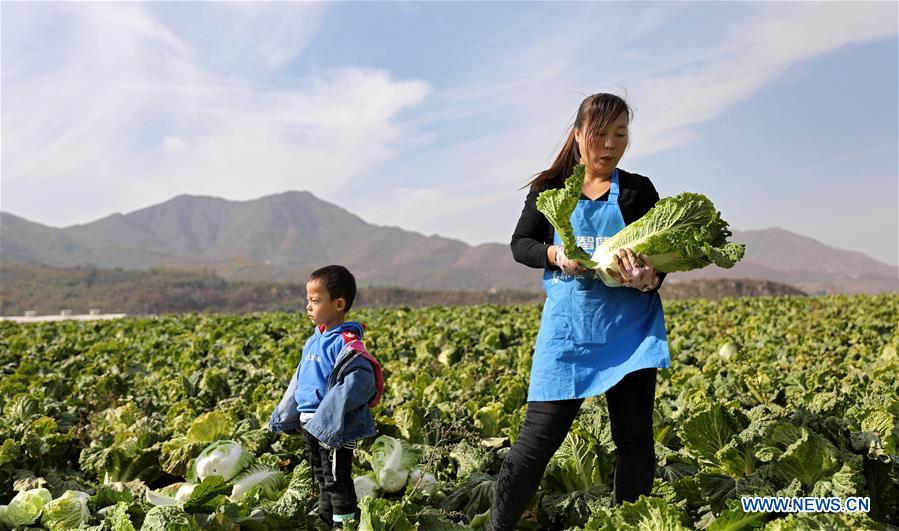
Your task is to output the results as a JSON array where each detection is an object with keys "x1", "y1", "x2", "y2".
[{"x1": 593, "y1": 192, "x2": 746, "y2": 287}]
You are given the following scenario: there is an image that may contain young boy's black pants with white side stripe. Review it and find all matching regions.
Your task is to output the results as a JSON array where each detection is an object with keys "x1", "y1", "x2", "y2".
[{"x1": 302, "y1": 429, "x2": 359, "y2": 527}]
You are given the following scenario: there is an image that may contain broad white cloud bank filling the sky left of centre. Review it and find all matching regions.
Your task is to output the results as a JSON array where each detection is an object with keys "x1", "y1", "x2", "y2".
[{"x1": 3, "y1": 3, "x2": 429, "y2": 224}]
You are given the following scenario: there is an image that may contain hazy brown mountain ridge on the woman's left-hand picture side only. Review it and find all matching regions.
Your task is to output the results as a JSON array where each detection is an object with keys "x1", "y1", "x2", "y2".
[{"x1": 0, "y1": 192, "x2": 540, "y2": 291}]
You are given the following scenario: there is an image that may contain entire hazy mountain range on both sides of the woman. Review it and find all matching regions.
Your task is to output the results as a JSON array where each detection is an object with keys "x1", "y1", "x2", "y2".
[{"x1": 0, "y1": 192, "x2": 899, "y2": 294}]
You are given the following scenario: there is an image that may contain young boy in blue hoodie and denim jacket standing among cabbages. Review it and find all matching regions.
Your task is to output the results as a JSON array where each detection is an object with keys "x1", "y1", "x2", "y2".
[{"x1": 270, "y1": 265, "x2": 383, "y2": 528}]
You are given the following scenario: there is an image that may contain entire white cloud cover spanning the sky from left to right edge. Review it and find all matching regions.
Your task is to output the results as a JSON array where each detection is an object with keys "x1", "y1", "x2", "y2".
[{"x1": 2, "y1": 2, "x2": 896, "y2": 270}]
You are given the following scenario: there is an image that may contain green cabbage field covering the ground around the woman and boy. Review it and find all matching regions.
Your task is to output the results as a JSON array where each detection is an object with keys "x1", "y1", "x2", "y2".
[{"x1": 0, "y1": 295, "x2": 899, "y2": 530}]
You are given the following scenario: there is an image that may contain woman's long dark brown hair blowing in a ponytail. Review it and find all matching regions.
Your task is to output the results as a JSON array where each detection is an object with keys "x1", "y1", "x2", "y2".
[{"x1": 523, "y1": 92, "x2": 633, "y2": 190}]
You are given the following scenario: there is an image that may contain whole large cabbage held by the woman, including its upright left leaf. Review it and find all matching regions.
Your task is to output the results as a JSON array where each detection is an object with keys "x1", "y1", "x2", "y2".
[{"x1": 537, "y1": 165, "x2": 746, "y2": 287}]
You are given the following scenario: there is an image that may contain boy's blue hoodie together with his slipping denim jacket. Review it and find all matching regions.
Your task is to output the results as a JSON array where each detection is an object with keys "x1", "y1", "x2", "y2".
[{"x1": 269, "y1": 321, "x2": 377, "y2": 448}]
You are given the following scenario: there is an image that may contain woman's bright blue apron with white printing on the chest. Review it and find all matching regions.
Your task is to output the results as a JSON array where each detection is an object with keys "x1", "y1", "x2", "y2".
[{"x1": 528, "y1": 169, "x2": 671, "y2": 401}]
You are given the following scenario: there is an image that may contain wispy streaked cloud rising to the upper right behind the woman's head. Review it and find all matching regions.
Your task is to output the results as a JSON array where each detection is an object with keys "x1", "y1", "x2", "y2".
[{"x1": 361, "y1": 3, "x2": 896, "y2": 248}]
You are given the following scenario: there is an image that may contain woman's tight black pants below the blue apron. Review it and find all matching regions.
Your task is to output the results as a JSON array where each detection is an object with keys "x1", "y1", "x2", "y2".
[{"x1": 488, "y1": 368, "x2": 656, "y2": 531}]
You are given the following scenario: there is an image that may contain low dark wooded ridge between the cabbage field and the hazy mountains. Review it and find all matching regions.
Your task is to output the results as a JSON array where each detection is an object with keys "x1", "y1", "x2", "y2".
[{"x1": 0, "y1": 264, "x2": 802, "y2": 316}]
